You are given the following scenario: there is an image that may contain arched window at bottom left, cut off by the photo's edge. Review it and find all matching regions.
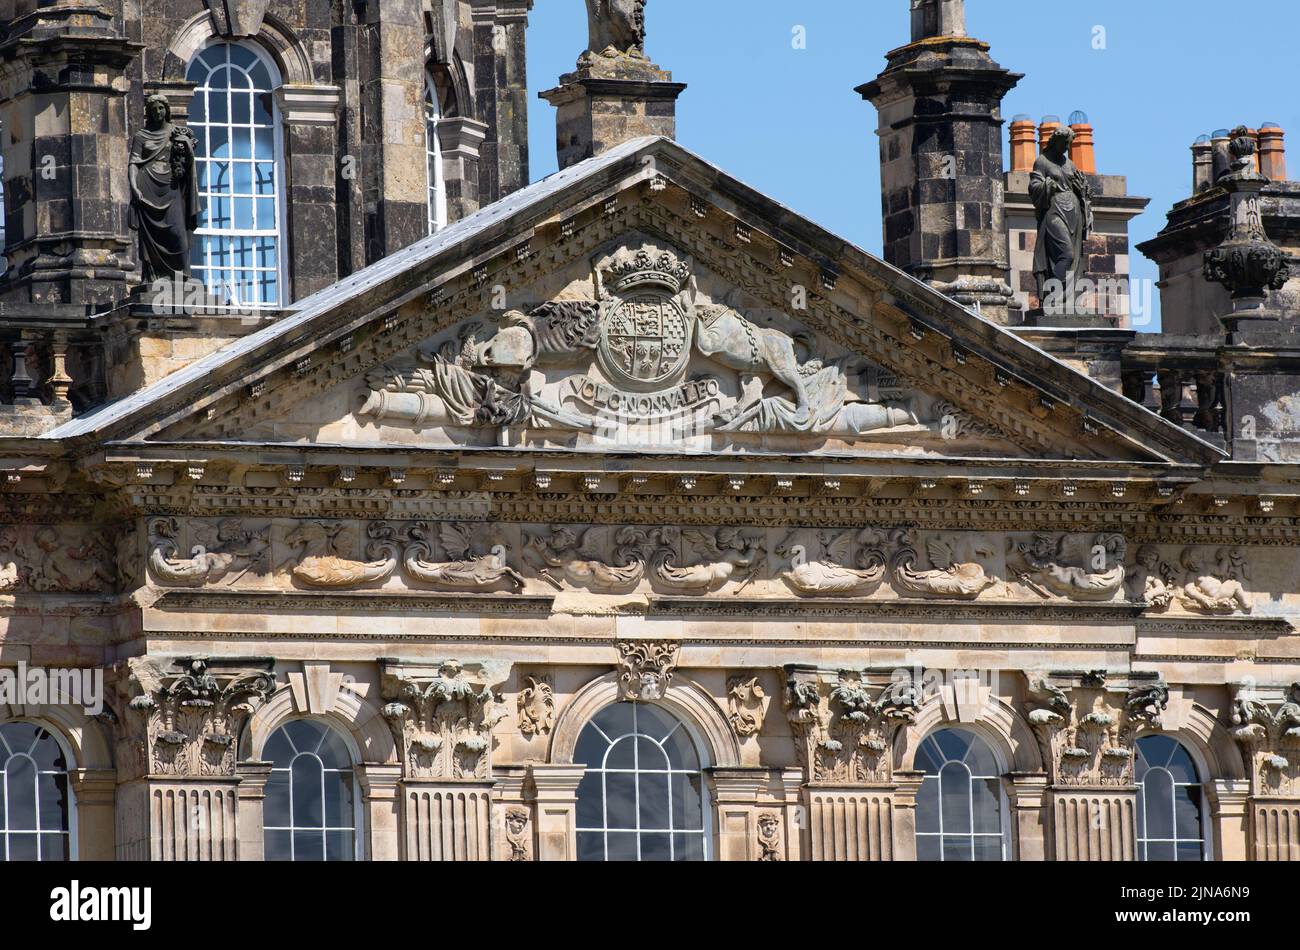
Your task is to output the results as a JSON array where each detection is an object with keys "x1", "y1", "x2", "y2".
[{"x1": 0, "y1": 723, "x2": 70, "y2": 860}]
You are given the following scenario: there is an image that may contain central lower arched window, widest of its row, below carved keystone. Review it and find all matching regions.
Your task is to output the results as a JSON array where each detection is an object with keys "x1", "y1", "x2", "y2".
[{"x1": 573, "y1": 703, "x2": 707, "y2": 860}]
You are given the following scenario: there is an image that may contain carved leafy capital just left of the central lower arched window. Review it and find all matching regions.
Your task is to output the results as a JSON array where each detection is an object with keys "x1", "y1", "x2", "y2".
[{"x1": 380, "y1": 660, "x2": 510, "y2": 780}]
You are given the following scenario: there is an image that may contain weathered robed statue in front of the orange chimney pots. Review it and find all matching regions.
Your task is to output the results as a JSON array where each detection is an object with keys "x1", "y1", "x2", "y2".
[{"x1": 1030, "y1": 126, "x2": 1092, "y2": 309}]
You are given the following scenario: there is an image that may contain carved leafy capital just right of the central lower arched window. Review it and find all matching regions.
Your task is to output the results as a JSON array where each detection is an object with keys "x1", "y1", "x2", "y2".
[{"x1": 785, "y1": 667, "x2": 918, "y2": 785}]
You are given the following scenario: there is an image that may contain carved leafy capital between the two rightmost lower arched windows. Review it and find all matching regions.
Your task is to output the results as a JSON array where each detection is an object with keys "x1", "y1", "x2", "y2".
[{"x1": 1026, "y1": 672, "x2": 1169, "y2": 788}]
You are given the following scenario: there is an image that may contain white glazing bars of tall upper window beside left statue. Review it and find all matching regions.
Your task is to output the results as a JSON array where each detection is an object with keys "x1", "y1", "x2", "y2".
[{"x1": 186, "y1": 36, "x2": 290, "y2": 311}]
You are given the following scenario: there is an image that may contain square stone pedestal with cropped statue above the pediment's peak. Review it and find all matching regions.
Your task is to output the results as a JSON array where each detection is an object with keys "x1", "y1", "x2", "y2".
[{"x1": 538, "y1": 0, "x2": 686, "y2": 169}]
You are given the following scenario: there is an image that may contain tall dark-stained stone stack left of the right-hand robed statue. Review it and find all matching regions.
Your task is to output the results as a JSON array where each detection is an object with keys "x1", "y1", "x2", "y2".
[{"x1": 857, "y1": 0, "x2": 1032, "y2": 324}]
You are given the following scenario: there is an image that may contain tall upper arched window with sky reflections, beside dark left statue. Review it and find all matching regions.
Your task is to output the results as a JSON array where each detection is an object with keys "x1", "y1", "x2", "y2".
[{"x1": 186, "y1": 43, "x2": 285, "y2": 308}]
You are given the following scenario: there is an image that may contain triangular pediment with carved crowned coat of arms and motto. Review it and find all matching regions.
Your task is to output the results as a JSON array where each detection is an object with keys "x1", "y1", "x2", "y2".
[{"x1": 40, "y1": 139, "x2": 1216, "y2": 473}]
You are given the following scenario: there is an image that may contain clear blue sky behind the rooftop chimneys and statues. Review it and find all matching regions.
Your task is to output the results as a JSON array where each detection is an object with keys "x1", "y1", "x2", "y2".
[{"x1": 528, "y1": 0, "x2": 1300, "y2": 330}]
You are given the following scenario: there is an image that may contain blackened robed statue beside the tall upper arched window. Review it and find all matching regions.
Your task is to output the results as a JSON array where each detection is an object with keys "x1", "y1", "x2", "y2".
[{"x1": 130, "y1": 95, "x2": 203, "y2": 283}]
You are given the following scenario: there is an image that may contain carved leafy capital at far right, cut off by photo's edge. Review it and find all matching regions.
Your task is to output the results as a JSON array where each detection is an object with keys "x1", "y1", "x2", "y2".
[{"x1": 1232, "y1": 682, "x2": 1300, "y2": 798}]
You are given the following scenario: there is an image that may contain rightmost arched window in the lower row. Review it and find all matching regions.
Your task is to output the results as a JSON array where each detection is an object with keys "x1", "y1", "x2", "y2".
[{"x1": 1134, "y1": 736, "x2": 1205, "y2": 860}]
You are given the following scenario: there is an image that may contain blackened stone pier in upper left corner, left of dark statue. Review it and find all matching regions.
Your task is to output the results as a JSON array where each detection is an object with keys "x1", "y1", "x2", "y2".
[{"x1": 0, "y1": 0, "x2": 140, "y2": 304}]
